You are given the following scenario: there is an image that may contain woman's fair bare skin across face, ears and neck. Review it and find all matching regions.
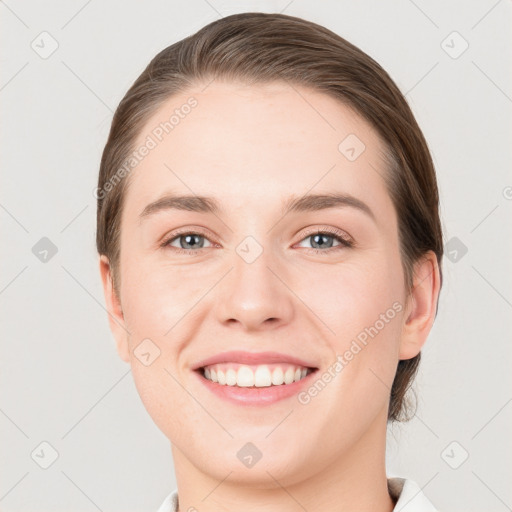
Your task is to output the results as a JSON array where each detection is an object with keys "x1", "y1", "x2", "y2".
[{"x1": 99, "y1": 81, "x2": 440, "y2": 512}]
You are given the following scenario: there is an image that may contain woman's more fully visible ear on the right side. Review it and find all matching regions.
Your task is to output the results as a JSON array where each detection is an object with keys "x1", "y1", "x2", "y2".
[{"x1": 399, "y1": 251, "x2": 441, "y2": 359}]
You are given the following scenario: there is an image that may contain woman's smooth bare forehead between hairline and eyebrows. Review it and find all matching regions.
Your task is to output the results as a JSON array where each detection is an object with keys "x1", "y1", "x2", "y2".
[{"x1": 125, "y1": 81, "x2": 390, "y2": 222}]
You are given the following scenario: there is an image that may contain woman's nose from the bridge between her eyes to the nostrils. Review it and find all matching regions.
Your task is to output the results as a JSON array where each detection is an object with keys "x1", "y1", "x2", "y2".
[{"x1": 216, "y1": 236, "x2": 293, "y2": 329}]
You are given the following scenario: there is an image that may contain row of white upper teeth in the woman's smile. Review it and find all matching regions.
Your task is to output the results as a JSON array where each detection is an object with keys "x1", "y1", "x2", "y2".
[{"x1": 203, "y1": 363, "x2": 309, "y2": 388}]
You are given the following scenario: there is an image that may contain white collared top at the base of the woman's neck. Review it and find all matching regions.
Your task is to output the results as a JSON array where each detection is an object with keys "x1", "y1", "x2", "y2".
[{"x1": 157, "y1": 478, "x2": 439, "y2": 512}]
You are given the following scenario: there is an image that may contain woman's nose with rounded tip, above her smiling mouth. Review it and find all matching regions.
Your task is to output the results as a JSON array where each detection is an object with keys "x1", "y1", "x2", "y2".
[{"x1": 214, "y1": 247, "x2": 294, "y2": 331}]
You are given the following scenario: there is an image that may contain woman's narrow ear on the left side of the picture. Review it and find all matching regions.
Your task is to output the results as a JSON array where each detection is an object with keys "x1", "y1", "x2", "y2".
[{"x1": 99, "y1": 255, "x2": 130, "y2": 363}]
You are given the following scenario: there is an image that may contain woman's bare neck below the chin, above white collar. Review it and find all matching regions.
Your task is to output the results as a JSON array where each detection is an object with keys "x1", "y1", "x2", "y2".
[{"x1": 171, "y1": 411, "x2": 394, "y2": 512}]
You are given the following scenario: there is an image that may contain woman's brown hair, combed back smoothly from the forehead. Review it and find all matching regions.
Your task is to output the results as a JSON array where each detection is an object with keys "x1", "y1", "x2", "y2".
[{"x1": 96, "y1": 12, "x2": 443, "y2": 421}]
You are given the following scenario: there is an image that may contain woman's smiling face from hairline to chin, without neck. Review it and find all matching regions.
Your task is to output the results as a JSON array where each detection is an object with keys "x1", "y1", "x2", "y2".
[{"x1": 101, "y1": 82, "x2": 436, "y2": 484}]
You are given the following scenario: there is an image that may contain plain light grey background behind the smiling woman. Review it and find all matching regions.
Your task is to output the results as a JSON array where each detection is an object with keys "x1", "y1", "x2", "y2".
[{"x1": 0, "y1": 0, "x2": 512, "y2": 512}]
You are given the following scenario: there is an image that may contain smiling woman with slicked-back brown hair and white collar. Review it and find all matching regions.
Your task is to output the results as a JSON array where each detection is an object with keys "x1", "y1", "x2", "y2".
[{"x1": 97, "y1": 13, "x2": 443, "y2": 512}]
